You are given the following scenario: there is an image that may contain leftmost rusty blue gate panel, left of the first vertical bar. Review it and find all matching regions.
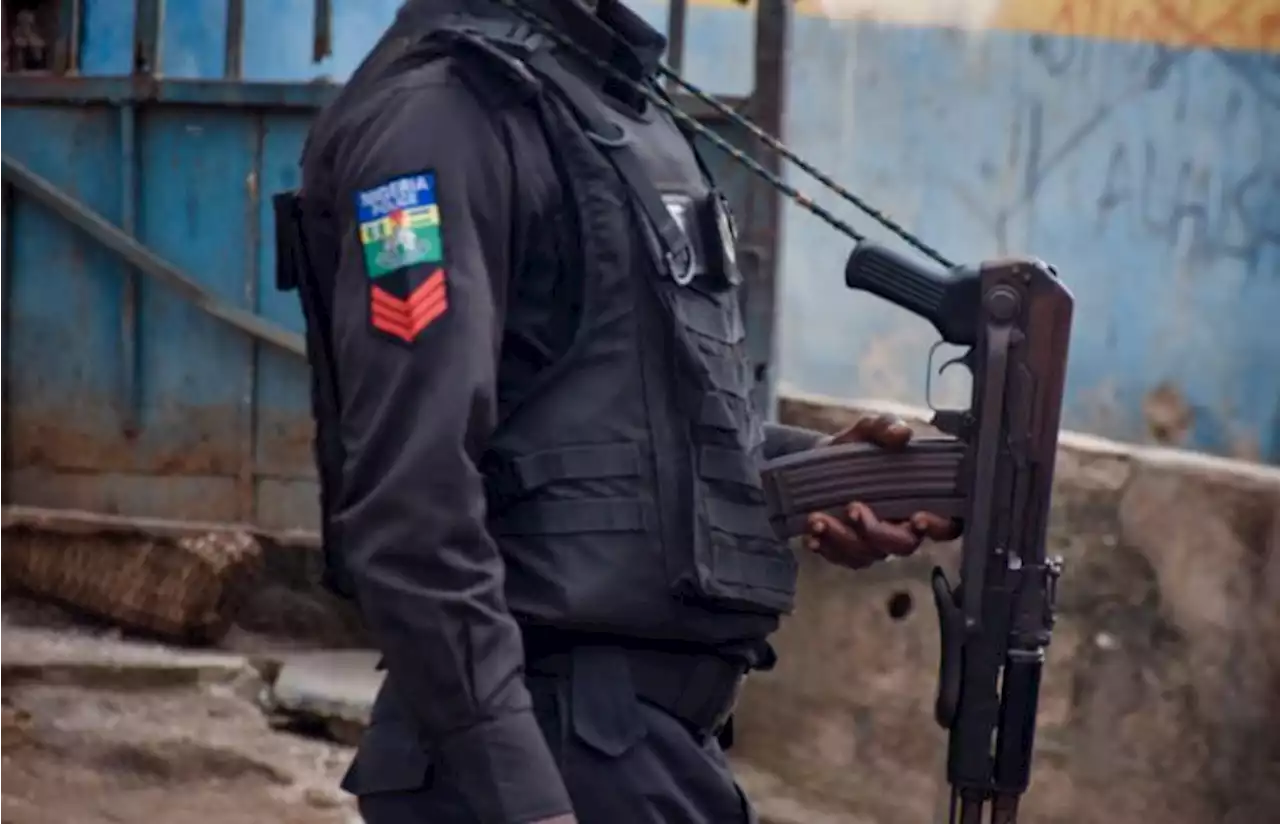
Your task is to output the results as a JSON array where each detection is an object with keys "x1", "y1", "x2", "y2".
[{"x1": 0, "y1": 106, "x2": 131, "y2": 499}]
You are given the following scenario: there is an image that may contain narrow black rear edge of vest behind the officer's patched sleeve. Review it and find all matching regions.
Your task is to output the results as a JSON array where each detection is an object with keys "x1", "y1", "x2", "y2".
[{"x1": 271, "y1": 192, "x2": 353, "y2": 598}]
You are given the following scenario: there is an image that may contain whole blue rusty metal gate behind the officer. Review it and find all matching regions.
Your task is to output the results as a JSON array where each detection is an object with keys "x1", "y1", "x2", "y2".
[{"x1": 0, "y1": 0, "x2": 787, "y2": 530}]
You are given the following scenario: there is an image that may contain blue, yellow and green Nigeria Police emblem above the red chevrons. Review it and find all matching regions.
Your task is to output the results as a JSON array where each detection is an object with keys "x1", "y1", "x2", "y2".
[{"x1": 356, "y1": 171, "x2": 444, "y2": 280}]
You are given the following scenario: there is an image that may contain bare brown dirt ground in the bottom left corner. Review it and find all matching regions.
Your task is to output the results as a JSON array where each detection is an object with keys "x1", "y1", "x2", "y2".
[{"x1": 0, "y1": 685, "x2": 360, "y2": 824}]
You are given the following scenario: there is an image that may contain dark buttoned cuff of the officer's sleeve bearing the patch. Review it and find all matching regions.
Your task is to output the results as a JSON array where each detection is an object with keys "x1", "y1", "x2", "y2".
[{"x1": 439, "y1": 710, "x2": 572, "y2": 824}]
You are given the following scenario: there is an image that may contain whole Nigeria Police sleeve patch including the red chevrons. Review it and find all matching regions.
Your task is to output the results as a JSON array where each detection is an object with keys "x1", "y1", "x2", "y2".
[{"x1": 356, "y1": 171, "x2": 448, "y2": 342}]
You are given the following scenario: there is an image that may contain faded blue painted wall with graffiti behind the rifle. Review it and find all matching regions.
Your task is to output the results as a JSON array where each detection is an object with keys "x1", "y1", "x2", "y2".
[{"x1": 780, "y1": 18, "x2": 1280, "y2": 463}]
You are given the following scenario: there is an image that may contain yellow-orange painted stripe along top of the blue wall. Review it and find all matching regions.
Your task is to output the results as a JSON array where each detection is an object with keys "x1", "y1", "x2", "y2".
[{"x1": 689, "y1": 0, "x2": 1280, "y2": 52}]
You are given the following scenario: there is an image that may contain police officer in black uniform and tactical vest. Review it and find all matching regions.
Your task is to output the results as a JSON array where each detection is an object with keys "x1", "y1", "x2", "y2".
[{"x1": 278, "y1": 0, "x2": 952, "y2": 824}]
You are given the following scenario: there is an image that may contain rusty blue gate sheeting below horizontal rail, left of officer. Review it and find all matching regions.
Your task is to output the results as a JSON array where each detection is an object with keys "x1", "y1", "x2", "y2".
[{"x1": 0, "y1": 99, "x2": 325, "y2": 527}]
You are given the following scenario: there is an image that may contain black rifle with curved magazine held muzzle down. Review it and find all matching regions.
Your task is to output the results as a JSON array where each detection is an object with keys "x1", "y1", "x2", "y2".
[{"x1": 763, "y1": 244, "x2": 1074, "y2": 824}]
